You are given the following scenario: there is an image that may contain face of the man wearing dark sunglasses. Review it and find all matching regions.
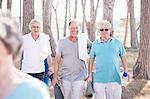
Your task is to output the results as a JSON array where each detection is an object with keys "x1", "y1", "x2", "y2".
[{"x1": 99, "y1": 24, "x2": 111, "y2": 40}]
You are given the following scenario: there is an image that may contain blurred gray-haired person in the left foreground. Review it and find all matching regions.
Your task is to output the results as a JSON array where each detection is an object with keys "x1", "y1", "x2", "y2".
[{"x1": 0, "y1": 13, "x2": 50, "y2": 99}]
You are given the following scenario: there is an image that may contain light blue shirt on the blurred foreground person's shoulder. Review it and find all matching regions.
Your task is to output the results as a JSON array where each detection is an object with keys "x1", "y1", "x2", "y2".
[{"x1": 6, "y1": 75, "x2": 50, "y2": 99}]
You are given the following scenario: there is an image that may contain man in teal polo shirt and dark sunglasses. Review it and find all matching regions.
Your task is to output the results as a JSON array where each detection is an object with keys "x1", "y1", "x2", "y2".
[{"x1": 87, "y1": 20, "x2": 128, "y2": 99}]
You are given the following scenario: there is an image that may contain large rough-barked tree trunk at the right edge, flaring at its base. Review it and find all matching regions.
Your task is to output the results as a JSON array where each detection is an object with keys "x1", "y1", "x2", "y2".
[{"x1": 133, "y1": 0, "x2": 150, "y2": 80}]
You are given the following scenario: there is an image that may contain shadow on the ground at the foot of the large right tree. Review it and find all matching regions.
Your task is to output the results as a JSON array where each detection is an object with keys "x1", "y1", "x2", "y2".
[{"x1": 121, "y1": 79, "x2": 147, "y2": 99}]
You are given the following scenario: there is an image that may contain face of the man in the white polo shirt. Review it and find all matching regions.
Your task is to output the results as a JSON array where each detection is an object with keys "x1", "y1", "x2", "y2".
[{"x1": 31, "y1": 22, "x2": 41, "y2": 35}]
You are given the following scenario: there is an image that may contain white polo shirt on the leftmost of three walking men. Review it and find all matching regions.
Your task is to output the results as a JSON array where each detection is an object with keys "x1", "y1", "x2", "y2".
[{"x1": 22, "y1": 33, "x2": 51, "y2": 73}]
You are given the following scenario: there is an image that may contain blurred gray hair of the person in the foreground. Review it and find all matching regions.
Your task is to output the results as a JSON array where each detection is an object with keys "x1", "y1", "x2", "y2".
[{"x1": 0, "y1": 12, "x2": 22, "y2": 58}]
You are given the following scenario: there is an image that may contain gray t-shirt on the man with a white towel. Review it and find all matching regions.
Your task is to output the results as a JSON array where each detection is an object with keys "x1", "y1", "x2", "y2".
[{"x1": 57, "y1": 37, "x2": 87, "y2": 81}]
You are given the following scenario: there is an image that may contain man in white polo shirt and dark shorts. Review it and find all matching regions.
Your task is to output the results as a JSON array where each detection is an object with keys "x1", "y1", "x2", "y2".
[{"x1": 21, "y1": 19, "x2": 51, "y2": 80}]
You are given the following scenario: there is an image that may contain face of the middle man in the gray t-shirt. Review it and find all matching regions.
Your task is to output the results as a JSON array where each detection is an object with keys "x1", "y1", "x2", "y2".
[{"x1": 69, "y1": 22, "x2": 79, "y2": 37}]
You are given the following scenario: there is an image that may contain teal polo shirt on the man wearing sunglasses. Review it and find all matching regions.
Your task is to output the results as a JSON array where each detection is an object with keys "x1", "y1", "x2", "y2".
[{"x1": 90, "y1": 37, "x2": 126, "y2": 84}]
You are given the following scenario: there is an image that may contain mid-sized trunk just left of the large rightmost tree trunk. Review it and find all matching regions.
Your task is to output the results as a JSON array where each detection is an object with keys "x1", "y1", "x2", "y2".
[{"x1": 129, "y1": 0, "x2": 138, "y2": 49}]
